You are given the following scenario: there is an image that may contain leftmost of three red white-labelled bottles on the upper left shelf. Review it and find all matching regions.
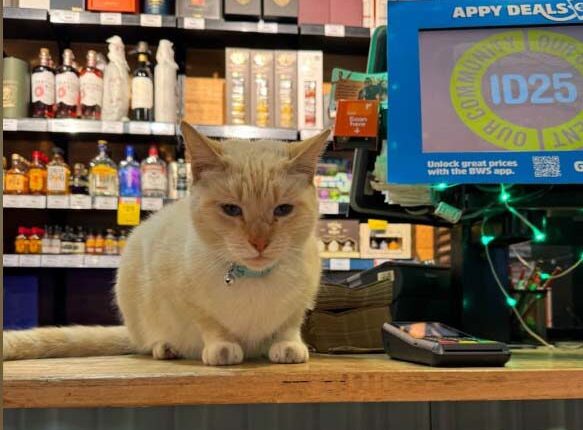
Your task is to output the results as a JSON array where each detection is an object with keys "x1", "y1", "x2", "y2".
[{"x1": 30, "y1": 48, "x2": 55, "y2": 118}]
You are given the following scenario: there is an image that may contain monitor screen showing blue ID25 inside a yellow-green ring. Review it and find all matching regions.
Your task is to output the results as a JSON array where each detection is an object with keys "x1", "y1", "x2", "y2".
[{"x1": 419, "y1": 26, "x2": 583, "y2": 154}]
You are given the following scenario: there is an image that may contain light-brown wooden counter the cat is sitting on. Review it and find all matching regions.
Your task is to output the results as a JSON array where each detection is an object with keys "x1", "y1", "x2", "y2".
[{"x1": 3, "y1": 350, "x2": 583, "y2": 408}]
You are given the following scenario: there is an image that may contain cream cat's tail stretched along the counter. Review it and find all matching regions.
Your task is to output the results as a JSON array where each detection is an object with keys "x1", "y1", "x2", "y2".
[{"x1": 3, "y1": 326, "x2": 137, "y2": 360}]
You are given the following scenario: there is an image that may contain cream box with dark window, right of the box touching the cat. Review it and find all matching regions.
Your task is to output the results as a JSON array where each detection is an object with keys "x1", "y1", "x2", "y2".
[{"x1": 360, "y1": 223, "x2": 413, "y2": 260}]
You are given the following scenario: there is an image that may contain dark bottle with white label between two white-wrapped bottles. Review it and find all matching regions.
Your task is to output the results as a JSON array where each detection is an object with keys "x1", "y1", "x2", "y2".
[{"x1": 130, "y1": 42, "x2": 154, "y2": 121}]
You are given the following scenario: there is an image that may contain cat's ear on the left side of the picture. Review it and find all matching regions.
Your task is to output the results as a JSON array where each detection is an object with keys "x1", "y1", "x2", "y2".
[{"x1": 180, "y1": 121, "x2": 225, "y2": 182}]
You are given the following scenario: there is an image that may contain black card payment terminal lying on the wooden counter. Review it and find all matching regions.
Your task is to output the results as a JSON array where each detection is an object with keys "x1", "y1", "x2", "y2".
[{"x1": 382, "y1": 322, "x2": 510, "y2": 366}]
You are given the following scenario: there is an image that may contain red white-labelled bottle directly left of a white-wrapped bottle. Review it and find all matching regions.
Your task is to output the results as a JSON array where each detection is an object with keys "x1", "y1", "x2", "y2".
[{"x1": 79, "y1": 49, "x2": 103, "y2": 119}]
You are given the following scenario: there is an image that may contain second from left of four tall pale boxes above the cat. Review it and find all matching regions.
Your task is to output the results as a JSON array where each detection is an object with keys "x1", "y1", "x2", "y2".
[{"x1": 251, "y1": 50, "x2": 274, "y2": 127}]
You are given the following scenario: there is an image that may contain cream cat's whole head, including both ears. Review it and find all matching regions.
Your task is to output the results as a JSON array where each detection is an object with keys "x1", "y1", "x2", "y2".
[{"x1": 183, "y1": 125, "x2": 328, "y2": 270}]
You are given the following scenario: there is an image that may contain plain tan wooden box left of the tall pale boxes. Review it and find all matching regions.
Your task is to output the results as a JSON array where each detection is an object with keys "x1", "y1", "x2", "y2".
[{"x1": 184, "y1": 78, "x2": 225, "y2": 125}]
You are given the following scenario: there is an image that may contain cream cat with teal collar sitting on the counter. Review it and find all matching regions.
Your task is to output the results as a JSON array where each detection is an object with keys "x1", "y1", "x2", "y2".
[{"x1": 4, "y1": 122, "x2": 329, "y2": 365}]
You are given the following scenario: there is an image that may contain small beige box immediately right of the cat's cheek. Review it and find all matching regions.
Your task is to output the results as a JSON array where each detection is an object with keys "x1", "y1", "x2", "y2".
[{"x1": 317, "y1": 220, "x2": 360, "y2": 258}]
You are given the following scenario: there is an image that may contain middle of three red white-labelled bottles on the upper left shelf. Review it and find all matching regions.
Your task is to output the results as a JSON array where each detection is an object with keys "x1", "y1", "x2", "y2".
[{"x1": 55, "y1": 49, "x2": 79, "y2": 118}]
